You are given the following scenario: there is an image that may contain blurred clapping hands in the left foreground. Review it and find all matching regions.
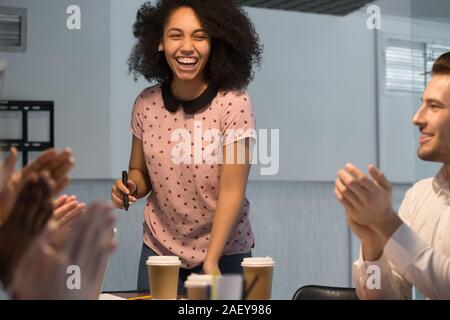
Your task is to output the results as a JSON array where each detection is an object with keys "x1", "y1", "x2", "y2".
[{"x1": 0, "y1": 149, "x2": 116, "y2": 299}]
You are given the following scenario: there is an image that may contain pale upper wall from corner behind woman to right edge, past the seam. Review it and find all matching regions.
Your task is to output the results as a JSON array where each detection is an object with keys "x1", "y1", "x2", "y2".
[{"x1": 111, "y1": 0, "x2": 449, "y2": 183}]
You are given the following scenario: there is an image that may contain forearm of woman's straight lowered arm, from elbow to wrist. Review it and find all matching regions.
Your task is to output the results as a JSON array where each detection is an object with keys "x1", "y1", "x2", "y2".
[{"x1": 205, "y1": 191, "x2": 244, "y2": 262}]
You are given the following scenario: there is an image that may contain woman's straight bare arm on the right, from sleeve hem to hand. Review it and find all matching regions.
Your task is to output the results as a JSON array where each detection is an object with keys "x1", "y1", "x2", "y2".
[{"x1": 203, "y1": 139, "x2": 251, "y2": 274}]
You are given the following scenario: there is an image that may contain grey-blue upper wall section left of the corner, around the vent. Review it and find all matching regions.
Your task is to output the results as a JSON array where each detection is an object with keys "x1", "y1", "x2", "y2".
[{"x1": 0, "y1": 0, "x2": 111, "y2": 179}]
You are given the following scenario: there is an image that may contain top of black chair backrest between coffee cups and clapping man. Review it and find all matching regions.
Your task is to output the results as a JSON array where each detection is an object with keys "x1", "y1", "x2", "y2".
[{"x1": 292, "y1": 285, "x2": 359, "y2": 300}]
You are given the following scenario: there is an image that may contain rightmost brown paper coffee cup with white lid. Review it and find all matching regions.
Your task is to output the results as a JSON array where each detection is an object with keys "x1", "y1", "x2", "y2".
[{"x1": 241, "y1": 257, "x2": 275, "y2": 300}]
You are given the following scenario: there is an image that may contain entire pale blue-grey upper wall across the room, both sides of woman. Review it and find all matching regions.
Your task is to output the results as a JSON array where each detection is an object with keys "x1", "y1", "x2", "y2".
[{"x1": 1, "y1": 0, "x2": 449, "y2": 183}]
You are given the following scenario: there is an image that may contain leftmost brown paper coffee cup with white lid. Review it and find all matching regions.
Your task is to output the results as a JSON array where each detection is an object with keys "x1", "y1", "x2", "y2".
[{"x1": 146, "y1": 256, "x2": 181, "y2": 300}]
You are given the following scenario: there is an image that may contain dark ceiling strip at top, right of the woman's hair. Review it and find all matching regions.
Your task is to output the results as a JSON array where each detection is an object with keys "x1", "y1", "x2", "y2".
[{"x1": 238, "y1": 0, "x2": 374, "y2": 16}]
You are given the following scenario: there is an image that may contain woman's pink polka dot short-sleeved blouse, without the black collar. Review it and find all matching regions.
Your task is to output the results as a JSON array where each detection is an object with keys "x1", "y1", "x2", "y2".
[{"x1": 131, "y1": 85, "x2": 255, "y2": 268}]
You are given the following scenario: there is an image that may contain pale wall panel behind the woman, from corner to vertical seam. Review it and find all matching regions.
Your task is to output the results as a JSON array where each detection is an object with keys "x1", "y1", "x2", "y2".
[{"x1": 111, "y1": 4, "x2": 375, "y2": 181}]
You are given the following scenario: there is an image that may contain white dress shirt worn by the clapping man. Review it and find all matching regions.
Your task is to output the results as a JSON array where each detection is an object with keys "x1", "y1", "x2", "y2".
[{"x1": 352, "y1": 167, "x2": 450, "y2": 299}]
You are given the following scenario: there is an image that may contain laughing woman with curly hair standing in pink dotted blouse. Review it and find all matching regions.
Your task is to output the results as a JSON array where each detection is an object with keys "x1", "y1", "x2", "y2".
[{"x1": 111, "y1": 0, "x2": 262, "y2": 294}]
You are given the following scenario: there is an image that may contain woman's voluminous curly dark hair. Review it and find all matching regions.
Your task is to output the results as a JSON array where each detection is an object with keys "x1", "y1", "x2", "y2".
[{"x1": 128, "y1": 0, "x2": 262, "y2": 90}]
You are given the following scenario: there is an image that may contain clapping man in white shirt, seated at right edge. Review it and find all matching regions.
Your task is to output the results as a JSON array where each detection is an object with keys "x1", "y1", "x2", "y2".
[{"x1": 335, "y1": 52, "x2": 450, "y2": 299}]
